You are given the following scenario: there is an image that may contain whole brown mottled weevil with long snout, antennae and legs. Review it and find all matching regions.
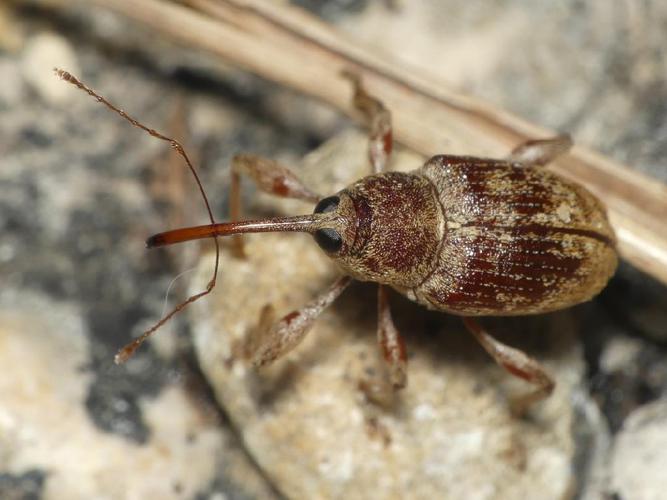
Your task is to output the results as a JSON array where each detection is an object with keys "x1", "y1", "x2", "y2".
[{"x1": 56, "y1": 70, "x2": 618, "y2": 411}]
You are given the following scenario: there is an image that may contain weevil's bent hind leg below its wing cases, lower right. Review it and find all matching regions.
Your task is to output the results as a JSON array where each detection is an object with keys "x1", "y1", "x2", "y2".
[{"x1": 463, "y1": 318, "x2": 555, "y2": 415}]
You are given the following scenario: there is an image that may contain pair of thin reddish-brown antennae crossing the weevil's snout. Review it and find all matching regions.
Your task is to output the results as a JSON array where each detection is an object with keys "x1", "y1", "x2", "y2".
[{"x1": 54, "y1": 68, "x2": 220, "y2": 364}]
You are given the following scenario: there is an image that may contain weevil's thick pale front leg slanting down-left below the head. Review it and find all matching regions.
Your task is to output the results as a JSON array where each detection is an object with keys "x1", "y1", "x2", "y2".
[{"x1": 252, "y1": 276, "x2": 352, "y2": 366}]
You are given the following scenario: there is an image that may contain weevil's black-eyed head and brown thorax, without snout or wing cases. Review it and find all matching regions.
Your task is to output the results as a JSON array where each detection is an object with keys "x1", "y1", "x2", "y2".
[{"x1": 313, "y1": 173, "x2": 444, "y2": 287}]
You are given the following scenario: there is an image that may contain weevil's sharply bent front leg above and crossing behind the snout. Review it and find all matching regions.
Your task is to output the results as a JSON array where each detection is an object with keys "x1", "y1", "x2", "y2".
[{"x1": 229, "y1": 155, "x2": 320, "y2": 256}]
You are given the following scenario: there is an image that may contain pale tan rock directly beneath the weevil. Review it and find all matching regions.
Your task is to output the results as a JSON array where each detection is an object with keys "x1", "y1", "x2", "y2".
[{"x1": 192, "y1": 133, "x2": 583, "y2": 499}]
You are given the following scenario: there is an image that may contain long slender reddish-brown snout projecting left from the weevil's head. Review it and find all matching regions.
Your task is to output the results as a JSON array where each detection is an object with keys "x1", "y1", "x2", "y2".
[{"x1": 146, "y1": 214, "x2": 325, "y2": 248}]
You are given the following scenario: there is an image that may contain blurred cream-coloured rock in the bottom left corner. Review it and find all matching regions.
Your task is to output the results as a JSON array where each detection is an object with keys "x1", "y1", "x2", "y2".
[{"x1": 0, "y1": 291, "x2": 271, "y2": 500}]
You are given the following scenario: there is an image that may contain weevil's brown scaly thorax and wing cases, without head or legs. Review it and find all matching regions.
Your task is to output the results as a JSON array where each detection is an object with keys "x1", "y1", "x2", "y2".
[{"x1": 325, "y1": 156, "x2": 616, "y2": 316}]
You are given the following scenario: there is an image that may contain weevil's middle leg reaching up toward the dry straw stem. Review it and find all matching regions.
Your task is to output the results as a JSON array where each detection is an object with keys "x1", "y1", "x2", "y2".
[{"x1": 343, "y1": 71, "x2": 393, "y2": 174}]
